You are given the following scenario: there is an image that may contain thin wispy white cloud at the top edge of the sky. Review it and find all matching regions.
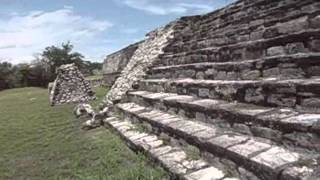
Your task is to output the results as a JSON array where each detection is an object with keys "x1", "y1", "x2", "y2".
[{"x1": 121, "y1": 0, "x2": 216, "y2": 15}]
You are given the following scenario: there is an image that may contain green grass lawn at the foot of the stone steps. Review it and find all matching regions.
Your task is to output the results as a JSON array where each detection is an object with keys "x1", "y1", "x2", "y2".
[{"x1": 0, "y1": 88, "x2": 168, "y2": 180}]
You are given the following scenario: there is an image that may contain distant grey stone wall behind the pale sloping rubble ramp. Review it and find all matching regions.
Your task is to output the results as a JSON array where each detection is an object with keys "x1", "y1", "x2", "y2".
[{"x1": 102, "y1": 42, "x2": 142, "y2": 86}]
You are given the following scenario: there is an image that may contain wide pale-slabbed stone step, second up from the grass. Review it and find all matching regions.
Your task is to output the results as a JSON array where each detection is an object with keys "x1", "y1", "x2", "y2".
[{"x1": 117, "y1": 103, "x2": 320, "y2": 180}]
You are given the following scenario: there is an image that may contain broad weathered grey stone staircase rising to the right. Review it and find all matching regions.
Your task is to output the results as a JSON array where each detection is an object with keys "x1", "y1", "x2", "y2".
[{"x1": 105, "y1": 0, "x2": 320, "y2": 180}]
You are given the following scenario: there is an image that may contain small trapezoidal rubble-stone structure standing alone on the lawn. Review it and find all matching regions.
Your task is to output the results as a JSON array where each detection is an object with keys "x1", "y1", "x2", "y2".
[{"x1": 49, "y1": 64, "x2": 95, "y2": 105}]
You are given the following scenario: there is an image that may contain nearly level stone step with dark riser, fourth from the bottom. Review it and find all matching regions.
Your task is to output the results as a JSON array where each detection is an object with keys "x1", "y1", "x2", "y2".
[{"x1": 139, "y1": 78, "x2": 320, "y2": 109}]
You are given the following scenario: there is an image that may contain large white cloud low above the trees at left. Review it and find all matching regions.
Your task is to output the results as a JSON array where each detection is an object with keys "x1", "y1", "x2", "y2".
[{"x1": 0, "y1": 6, "x2": 113, "y2": 63}]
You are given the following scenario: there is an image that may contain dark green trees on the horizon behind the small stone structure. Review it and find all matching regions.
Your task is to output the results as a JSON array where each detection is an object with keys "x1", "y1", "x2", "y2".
[{"x1": 0, "y1": 42, "x2": 102, "y2": 90}]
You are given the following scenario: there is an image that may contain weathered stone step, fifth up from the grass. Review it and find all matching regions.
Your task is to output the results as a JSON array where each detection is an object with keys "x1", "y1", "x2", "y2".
[{"x1": 148, "y1": 53, "x2": 320, "y2": 80}]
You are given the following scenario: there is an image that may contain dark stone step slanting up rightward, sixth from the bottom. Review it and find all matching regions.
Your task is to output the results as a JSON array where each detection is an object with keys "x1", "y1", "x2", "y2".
[{"x1": 158, "y1": 29, "x2": 320, "y2": 66}]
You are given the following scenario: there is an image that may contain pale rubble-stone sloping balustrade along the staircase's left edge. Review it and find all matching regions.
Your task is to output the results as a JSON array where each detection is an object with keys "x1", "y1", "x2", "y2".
[{"x1": 104, "y1": 22, "x2": 176, "y2": 106}]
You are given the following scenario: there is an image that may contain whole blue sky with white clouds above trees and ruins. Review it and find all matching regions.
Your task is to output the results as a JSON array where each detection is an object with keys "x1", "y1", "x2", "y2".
[{"x1": 0, "y1": 0, "x2": 234, "y2": 63}]
